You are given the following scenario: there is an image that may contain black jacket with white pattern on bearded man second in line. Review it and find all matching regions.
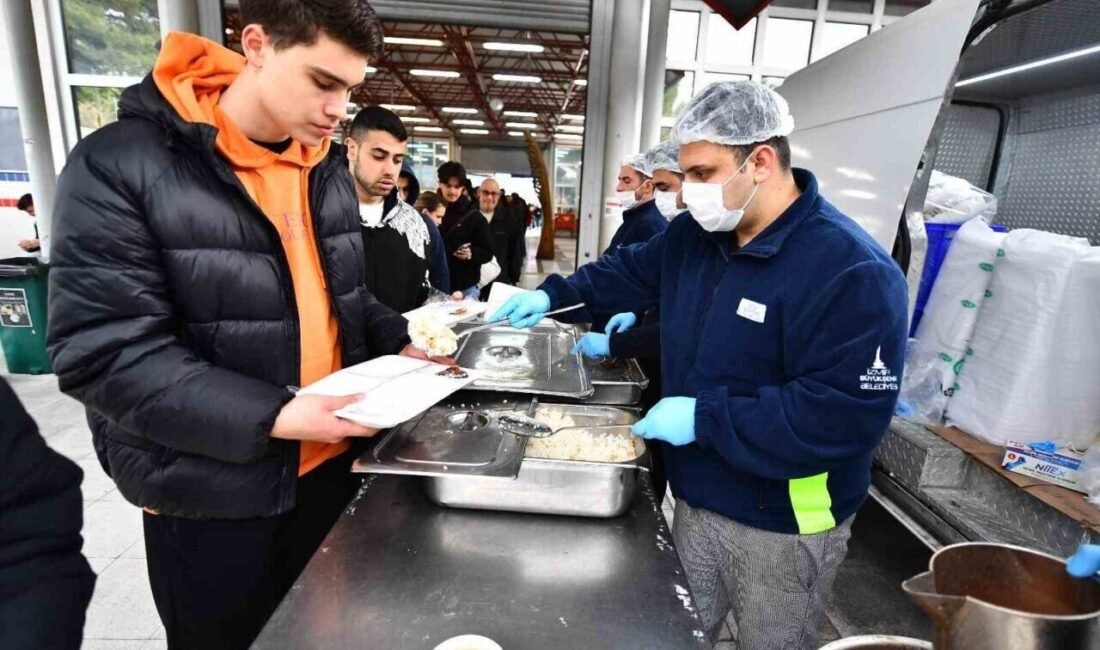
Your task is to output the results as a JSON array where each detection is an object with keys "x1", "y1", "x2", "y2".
[{"x1": 361, "y1": 192, "x2": 431, "y2": 313}]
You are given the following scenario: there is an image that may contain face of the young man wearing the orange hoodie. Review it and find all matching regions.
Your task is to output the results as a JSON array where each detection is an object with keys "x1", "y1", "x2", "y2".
[{"x1": 249, "y1": 25, "x2": 369, "y2": 146}]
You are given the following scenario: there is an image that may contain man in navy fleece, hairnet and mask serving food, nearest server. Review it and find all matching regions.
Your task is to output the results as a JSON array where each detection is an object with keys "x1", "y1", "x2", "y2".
[{"x1": 491, "y1": 81, "x2": 908, "y2": 650}]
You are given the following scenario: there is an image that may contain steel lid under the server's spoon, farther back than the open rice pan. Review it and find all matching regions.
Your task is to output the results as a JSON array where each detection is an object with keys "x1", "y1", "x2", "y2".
[{"x1": 454, "y1": 320, "x2": 594, "y2": 399}]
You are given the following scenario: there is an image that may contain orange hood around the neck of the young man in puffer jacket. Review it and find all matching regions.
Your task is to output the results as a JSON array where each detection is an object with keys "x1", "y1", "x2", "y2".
[{"x1": 153, "y1": 32, "x2": 330, "y2": 168}]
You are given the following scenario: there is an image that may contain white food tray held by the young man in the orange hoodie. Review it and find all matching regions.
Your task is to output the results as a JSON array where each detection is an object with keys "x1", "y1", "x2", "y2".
[{"x1": 299, "y1": 355, "x2": 479, "y2": 429}]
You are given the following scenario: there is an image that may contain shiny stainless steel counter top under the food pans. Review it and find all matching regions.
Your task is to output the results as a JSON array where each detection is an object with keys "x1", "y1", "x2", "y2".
[{"x1": 254, "y1": 473, "x2": 705, "y2": 650}]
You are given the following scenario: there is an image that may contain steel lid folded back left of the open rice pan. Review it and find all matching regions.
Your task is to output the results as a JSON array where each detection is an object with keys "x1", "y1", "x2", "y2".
[{"x1": 352, "y1": 395, "x2": 530, "y2": 478}]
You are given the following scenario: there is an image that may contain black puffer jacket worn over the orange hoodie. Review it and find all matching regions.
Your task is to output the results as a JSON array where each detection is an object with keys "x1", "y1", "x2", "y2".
[{"x1": 48, "y1": 77, "x2": 408, "y2": 518}]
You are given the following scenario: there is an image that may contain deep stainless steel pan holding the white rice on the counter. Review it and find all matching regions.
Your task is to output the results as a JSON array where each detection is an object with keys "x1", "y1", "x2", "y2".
[{"x1": 425, "y1": 404, "x2": 648, "y2": 518}]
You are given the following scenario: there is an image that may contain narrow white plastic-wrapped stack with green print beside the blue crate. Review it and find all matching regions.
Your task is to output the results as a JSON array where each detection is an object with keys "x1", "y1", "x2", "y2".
[{"x1": 916, "y1": 219, "x2": 1005, "y2": 404}]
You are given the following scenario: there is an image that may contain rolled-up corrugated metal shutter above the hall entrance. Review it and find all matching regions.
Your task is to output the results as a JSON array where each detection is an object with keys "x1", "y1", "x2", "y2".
[{"x1": 371, "y1": 0, "x2": 592, "y2": 34}]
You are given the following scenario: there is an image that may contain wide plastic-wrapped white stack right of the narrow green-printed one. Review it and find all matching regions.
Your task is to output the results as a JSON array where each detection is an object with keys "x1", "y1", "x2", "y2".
[{"x1": 947, "y1": 230, "x2": 1098, "y2": 447}]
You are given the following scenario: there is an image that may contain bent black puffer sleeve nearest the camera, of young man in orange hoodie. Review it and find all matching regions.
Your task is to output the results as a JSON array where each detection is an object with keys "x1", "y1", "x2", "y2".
[{"x1": 47, "y1": 147, "x2": 292, "y2": 463}]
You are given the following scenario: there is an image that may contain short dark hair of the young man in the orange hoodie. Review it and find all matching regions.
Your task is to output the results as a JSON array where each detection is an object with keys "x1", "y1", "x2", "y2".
[{"x1": 241, "y1": 0, "x2": 382, "y2": 58}]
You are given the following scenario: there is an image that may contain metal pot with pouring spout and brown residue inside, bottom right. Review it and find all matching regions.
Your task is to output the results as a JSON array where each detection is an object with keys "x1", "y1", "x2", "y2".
[{"x1": 902, "y1": 542, "x2": 1100, "y2": 650}]
